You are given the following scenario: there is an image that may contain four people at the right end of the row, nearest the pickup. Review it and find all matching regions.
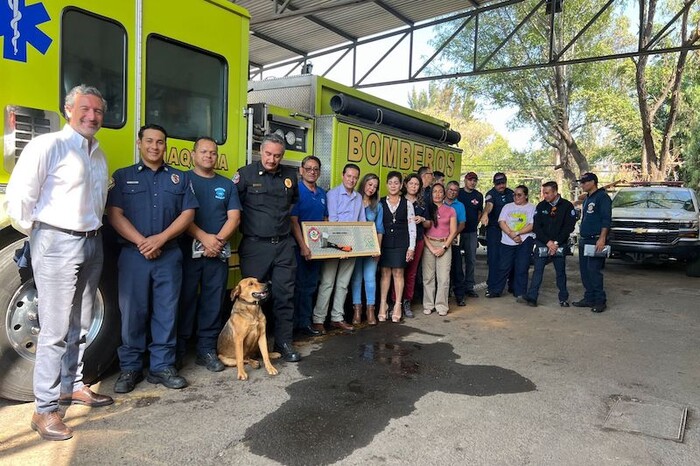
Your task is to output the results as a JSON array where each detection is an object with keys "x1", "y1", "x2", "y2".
[{"x1": 481, "y1": 173, "x2": 612, "y2": 313}]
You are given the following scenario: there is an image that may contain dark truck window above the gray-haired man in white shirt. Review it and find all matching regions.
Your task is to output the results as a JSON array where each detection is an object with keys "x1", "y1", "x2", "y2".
[{"x1": 59, "y1": 8, "x2": 126, "y2": 128}]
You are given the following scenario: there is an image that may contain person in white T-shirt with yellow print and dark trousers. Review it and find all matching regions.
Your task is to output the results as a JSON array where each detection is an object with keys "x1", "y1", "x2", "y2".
[{"x1": 488, "y1": 185, "x2": 535, "y2": 300}]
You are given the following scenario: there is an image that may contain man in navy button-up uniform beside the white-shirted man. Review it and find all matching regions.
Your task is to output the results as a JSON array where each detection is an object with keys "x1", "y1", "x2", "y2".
[{"x1": 107, "y1": 124, "x2": 199, "y2": 393}]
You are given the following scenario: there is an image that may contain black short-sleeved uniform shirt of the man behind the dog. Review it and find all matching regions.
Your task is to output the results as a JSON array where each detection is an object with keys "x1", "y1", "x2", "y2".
[{"x1": 233, "y1": 161, "x2": 299, "y2": 238}]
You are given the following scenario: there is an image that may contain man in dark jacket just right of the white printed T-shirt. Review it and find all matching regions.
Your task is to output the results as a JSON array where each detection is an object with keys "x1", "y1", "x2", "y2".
[{"x1": 524, "y1": 181, "x2": 576, "y2": 307}]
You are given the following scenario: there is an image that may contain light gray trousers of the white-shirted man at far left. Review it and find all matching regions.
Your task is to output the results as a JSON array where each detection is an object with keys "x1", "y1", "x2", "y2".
[{"x1": 30, "y1": 224, "x2": 103, "y2": 413}]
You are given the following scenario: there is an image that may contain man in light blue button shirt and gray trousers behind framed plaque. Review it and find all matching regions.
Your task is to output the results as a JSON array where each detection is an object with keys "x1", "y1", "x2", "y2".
[{"x1": 313, "y1": 163, "x2": 365, "y2": 333}]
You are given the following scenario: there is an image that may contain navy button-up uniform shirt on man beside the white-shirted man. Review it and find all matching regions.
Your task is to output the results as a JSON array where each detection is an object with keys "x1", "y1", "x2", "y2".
[{"x1": 107, "y1": 162, "x2": 199, "y2": 237}]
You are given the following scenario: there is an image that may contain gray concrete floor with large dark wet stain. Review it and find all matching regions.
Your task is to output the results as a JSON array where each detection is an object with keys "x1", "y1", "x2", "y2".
[{"x1": 0, "y1": 256, "x2": 700, "y2": 465}]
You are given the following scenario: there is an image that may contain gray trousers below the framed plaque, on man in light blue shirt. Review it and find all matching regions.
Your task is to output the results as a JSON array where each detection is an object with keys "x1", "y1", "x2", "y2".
[{"x1": 313, "y1": 257, "x2": 355, "y2": 324}]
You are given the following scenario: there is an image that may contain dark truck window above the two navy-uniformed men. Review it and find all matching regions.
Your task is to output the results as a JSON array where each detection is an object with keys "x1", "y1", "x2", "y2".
[{"x1": 146, "y1": 35, "x2": 228, "y2": 144}]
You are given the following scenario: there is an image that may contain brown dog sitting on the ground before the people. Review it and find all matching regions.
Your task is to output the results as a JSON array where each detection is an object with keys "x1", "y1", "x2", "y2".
[{"x1": 217, "y1": 278, "x2": 277, "y2": 380}]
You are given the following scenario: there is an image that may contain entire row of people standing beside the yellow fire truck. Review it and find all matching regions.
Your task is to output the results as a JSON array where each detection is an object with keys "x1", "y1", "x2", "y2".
[{"x1": 6, "y1": 85, "x2": 610, "y2": 440}]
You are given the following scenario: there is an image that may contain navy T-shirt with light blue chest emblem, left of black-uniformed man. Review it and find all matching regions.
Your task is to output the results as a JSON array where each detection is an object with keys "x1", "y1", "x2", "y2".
[{"x1": 187, "y1": 170, "x2": 241, "y2": 235}]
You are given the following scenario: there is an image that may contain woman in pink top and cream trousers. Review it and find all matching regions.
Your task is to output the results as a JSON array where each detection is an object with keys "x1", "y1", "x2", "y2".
[{"x1": 423, "y1": 183, "x2": 457, "y2": 316}]
